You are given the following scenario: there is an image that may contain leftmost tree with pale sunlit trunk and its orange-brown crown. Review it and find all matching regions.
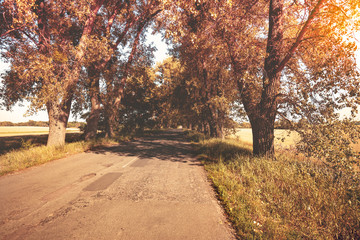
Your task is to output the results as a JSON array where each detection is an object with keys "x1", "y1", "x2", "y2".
[{"x1": 1, "y1": 0, "x2": 109, "y2": 145}]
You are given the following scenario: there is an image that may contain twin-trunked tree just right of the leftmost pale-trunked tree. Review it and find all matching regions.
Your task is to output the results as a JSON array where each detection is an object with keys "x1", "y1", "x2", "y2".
[{"x1": 80, "y1": 0, "x2": 161, "y2": 139}]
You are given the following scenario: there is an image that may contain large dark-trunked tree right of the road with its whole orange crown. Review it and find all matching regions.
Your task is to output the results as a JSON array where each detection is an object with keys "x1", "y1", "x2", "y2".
[{"x1": 162, "y1": 0, "x2": 359, "y2": 157}]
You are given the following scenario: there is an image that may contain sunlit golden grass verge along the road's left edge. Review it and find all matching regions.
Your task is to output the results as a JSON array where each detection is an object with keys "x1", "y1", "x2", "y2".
[{"x1": 0, "y1": 138, "x2": 117, "y2": 176}]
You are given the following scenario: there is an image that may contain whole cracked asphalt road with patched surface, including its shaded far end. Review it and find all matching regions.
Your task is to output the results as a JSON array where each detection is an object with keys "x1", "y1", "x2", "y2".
[{"x1": 0, "y1": 130, "x2": 235, "y2": 240}]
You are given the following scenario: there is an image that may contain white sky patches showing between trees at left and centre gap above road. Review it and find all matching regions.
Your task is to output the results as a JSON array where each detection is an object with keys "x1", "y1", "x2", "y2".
[{"x1": 0, "y1": 34, "x2": 168, "y2": 123}]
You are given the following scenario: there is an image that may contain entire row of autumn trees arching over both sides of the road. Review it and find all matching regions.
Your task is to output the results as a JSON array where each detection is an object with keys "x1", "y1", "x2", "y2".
[{"x1": 0, "y1": 0, "x2": 360, "y2": 167}]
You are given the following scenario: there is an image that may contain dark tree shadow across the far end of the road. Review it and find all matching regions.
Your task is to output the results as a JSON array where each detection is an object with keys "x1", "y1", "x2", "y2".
[{"x1": 88, "y1": 130, "x2": 199, "y2": 165}]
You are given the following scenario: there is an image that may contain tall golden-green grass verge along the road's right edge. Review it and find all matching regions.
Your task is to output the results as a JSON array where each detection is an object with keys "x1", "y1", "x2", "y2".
[{"x1": 188, "y1": 132, "x2": 360, "y2": 239}]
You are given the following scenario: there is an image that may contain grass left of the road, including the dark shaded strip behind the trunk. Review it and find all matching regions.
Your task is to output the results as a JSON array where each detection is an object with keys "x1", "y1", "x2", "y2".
[{"x1": 0, "y1": 130, "x2": 159, "y2": 176}]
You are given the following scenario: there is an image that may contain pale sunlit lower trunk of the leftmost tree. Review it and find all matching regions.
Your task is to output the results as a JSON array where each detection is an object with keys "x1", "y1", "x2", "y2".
[{"x1": 47, "y1": 100, "x2": 71, "y2": 146}]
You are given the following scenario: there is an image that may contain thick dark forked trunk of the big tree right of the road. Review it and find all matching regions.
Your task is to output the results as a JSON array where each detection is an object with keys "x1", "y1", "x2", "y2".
[{"x1": 242, "y1": 0, "x2": 284, "y2": 158}]
